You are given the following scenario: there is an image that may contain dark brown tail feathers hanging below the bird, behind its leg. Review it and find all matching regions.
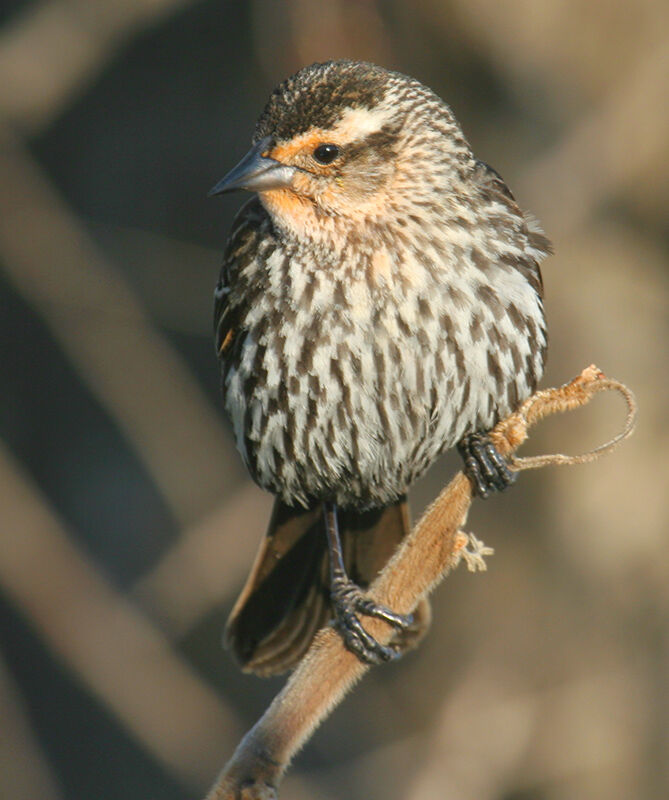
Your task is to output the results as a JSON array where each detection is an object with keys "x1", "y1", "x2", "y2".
[{"x1": 225, "y1": 498, "x2": 430, "y2": 676}]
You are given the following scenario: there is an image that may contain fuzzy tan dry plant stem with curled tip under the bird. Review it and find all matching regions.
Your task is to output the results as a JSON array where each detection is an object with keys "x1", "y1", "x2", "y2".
[{"x1": 206, "y1": 367, "x2": 636, "y2": 800}]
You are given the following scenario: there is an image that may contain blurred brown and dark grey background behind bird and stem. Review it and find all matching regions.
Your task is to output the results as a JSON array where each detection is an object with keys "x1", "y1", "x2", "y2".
[{"x1": 0, "y1": 0, "x2": 669, "y2": 800}]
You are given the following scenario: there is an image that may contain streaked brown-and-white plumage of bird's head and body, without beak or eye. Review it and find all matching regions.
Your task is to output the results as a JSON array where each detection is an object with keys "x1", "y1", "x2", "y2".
[{"x1": 215, "y1": 62, "x2": 549, "y2": 676}]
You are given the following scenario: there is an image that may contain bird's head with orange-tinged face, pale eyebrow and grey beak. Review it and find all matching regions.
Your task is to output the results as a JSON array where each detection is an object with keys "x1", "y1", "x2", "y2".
[{"x1": 211, "y1": 61, "x2": 469, "y2": 237}]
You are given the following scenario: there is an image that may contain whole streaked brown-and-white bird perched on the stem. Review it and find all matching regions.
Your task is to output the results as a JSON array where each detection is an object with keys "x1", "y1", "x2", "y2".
[{"x1": 210, "y1": 60, "x2": 552, "y2": 676}]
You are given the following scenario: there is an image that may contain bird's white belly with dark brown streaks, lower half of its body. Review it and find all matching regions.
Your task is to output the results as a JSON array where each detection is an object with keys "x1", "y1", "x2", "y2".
[{"x1": 224, "y1": 284, "x2": 545, "y2": 507}]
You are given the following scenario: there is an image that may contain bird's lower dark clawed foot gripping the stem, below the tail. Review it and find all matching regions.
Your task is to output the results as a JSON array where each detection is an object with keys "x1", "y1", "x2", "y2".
[{"x1": 330, "y1": 577, "x2": 414, "y2": 664}]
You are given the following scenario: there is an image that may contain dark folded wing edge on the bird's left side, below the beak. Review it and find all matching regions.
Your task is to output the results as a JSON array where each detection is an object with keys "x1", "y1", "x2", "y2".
[{"x1": 214, "y1": 195, "x2": 272, "y2": 357}]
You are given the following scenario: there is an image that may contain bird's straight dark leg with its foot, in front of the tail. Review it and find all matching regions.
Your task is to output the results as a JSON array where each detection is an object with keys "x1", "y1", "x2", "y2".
[{"x1": 323, "y1": 503, "x2": 413, "y2": 664}]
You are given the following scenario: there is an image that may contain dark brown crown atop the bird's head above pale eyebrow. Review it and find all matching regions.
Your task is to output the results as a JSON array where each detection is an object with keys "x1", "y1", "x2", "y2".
[{"x1": 254, "y1": 61, "x2": 395, "y2": 141}]
